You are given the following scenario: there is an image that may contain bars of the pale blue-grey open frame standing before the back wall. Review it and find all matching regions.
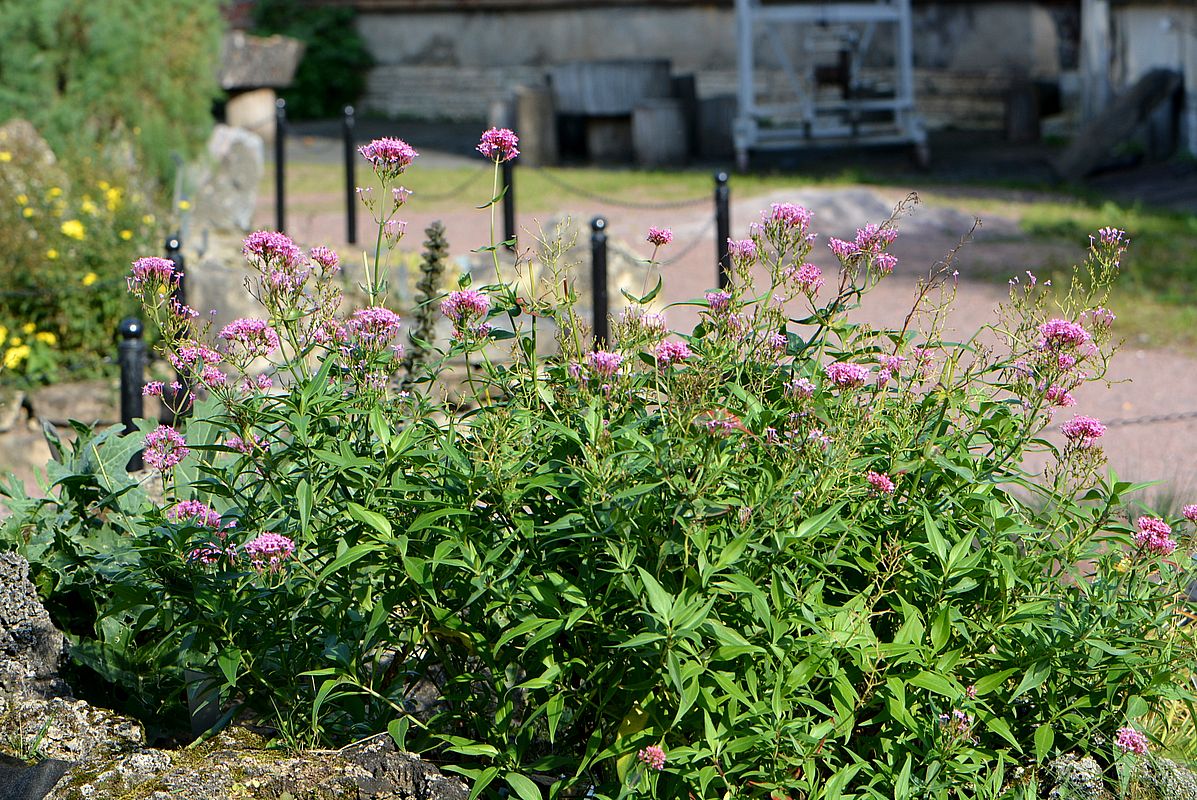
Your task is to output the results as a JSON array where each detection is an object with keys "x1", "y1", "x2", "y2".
[{"x1": 733, "y1": 0, "x2": 930, "y2": 169}]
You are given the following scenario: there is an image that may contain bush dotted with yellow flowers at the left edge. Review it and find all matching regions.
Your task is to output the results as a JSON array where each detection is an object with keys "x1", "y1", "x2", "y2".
[{"x1": 0, "y1": 129, "x2": 156, "y2": 383}]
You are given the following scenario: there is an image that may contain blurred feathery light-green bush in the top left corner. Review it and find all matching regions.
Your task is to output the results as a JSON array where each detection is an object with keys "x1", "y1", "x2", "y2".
[{"x1": 0, "y1": 0, "x2": 223, "y2": 183}]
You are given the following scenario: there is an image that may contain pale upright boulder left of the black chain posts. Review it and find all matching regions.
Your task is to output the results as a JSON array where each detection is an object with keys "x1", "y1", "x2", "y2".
[{"x1": 188, "y1": 125, "x2": 266, "y2": 232}]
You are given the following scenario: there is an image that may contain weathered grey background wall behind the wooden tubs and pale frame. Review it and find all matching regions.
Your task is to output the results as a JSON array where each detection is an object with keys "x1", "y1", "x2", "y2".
[{"x1": 358, "y1": 0, "x2": 1080, "y2": 127}]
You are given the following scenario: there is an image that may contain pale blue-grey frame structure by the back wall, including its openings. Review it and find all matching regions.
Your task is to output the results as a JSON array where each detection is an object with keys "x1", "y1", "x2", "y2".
[{"x1": 734, "y1": 0, "x2": 930, "y2": 170}]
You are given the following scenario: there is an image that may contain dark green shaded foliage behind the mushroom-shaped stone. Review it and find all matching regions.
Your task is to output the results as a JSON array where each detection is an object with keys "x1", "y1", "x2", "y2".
[{"x1": 254, "y1": 0, "x2": 373, "y2": 119}]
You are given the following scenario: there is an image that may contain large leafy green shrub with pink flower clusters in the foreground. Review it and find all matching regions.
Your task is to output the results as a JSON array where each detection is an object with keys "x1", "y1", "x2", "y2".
[{"x1": 6, "y1": 132, "x2": 1197, "y2": 799}]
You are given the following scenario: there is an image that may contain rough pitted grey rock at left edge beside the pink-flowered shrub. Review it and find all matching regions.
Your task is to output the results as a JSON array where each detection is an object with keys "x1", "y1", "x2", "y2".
[{"x1": 0, "y1": 553, "x2": 66, "y2": 694}]
